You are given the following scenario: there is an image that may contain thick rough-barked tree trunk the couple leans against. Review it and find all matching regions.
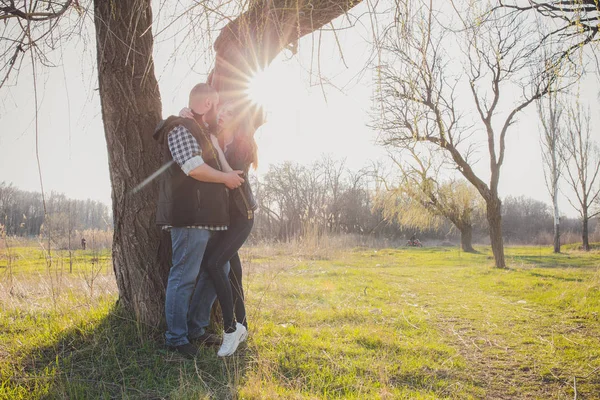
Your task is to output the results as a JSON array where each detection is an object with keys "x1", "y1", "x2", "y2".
[{"x1": 94, "y1": 0, "x2": 170, "y2": 327}]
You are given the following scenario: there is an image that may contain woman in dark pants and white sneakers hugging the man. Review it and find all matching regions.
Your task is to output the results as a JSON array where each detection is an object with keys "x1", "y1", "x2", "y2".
[{"x1": 180, "y1": 103, "x2": 257, "y2": 356}]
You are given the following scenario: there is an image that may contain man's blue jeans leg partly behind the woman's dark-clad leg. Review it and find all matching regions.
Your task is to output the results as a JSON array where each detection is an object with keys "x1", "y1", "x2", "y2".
[{"x1": 188, "y1": 262, "x2": 229, "y2": 339}]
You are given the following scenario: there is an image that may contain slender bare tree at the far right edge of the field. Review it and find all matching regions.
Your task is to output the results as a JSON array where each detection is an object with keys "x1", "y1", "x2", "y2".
[{"x1": 562, "y1": 105, "x2": 600, "y2": 251}]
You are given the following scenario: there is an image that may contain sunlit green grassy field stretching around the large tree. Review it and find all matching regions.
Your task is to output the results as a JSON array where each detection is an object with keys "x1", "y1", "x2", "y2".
[{"x1": 0, "y1": 242, "x2": 600, "y2": 399}]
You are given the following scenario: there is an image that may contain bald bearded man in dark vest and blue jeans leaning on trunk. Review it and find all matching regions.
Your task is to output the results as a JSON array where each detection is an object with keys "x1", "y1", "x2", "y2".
[{"x1": 154, "y1": 84, "x2": 244, "y2": 357}]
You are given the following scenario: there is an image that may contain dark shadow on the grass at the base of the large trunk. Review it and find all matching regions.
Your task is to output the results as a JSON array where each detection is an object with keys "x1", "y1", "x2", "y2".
[{"x1": 0, "y1": 307, "x2": 250, "y2": 399}]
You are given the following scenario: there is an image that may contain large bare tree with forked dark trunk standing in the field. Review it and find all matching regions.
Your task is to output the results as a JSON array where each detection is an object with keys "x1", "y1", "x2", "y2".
[{"x1": 375, "y1": 2, "x2": 553, "y2": 268}]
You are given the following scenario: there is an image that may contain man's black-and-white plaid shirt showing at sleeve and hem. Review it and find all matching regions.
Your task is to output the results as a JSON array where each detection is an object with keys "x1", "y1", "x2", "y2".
[{"x1": 163, "y1": 125, "x2": 227, "y2": 231}]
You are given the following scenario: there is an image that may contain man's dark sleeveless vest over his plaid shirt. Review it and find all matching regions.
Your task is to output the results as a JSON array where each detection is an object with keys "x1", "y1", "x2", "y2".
[{"x1": 154, "y1": 116, "x2": 229, "y2": 227}]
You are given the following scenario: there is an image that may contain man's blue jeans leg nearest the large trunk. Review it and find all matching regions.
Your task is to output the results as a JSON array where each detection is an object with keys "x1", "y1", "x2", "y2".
[{"x1": 165, "y1": 228, "x2": 214, "y2": 346}]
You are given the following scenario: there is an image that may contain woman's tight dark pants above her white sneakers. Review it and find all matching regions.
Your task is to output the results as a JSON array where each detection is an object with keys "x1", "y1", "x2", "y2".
[{"x1": 192, "y1": 204, "x2": 254, "y2": 333}]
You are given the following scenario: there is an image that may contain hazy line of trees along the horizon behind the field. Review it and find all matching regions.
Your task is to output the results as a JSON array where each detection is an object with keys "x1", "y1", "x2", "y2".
[{"x1": 0, "y1": 161, "x2": 600, "y2": 248}]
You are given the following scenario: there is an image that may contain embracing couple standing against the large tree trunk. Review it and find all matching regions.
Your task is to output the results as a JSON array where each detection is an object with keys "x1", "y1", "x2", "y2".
[{"x1": 154, "y1": 83, "x2": 257, "y2": 357}]
